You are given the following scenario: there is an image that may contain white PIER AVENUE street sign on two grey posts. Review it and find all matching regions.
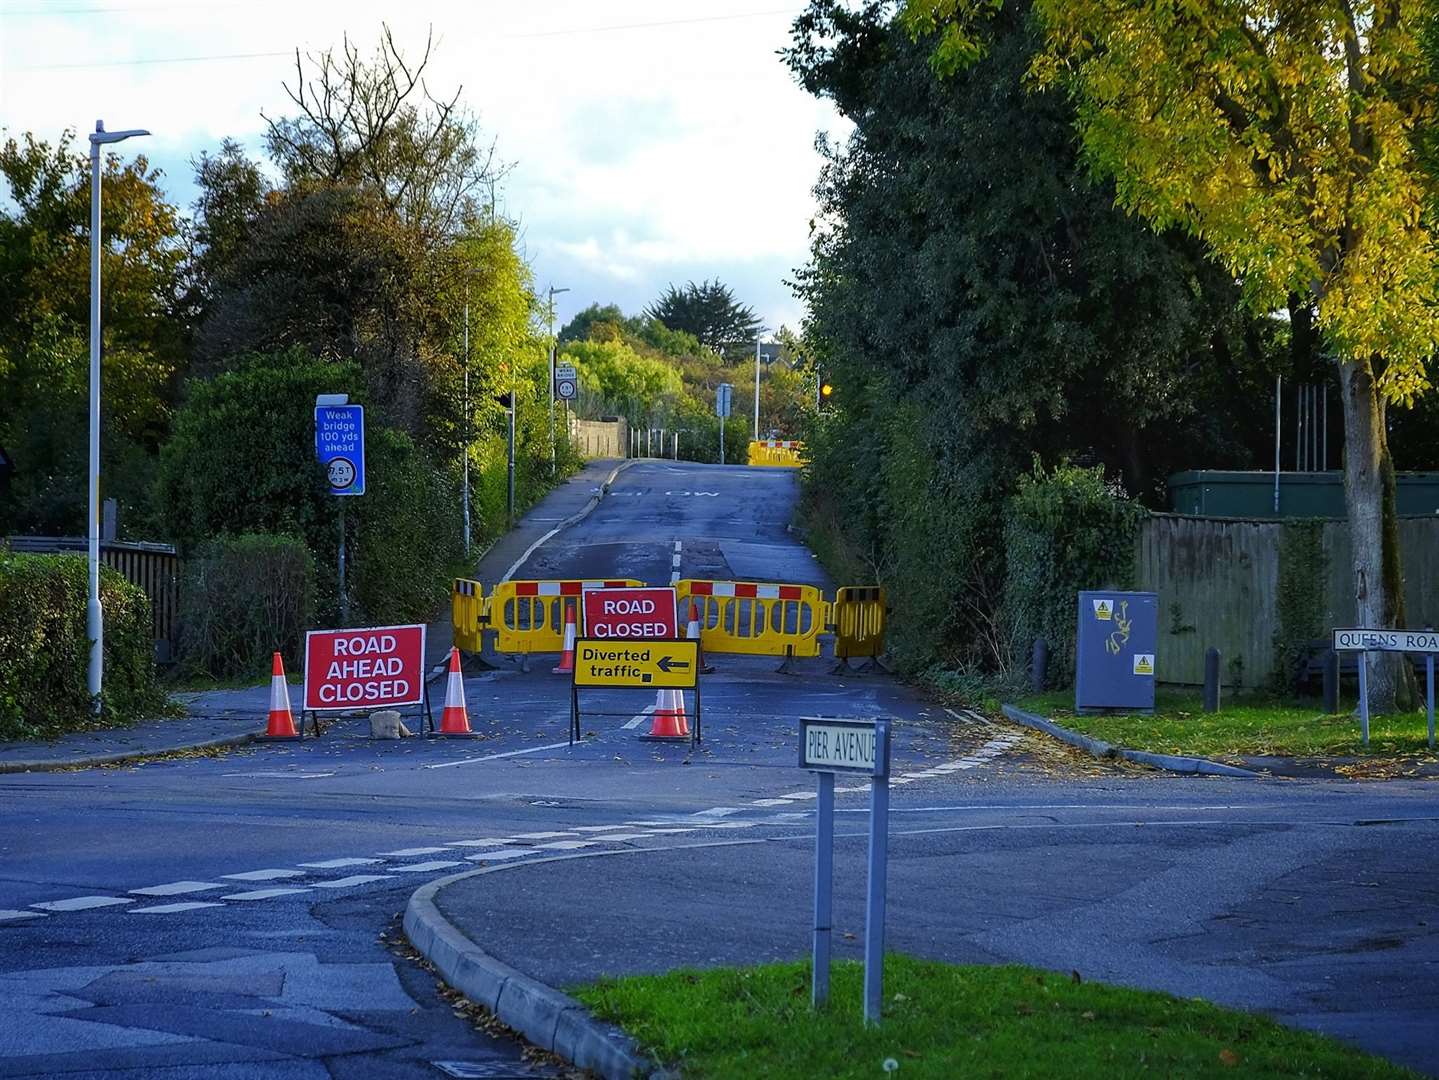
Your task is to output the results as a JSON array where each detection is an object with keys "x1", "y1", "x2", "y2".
[{"x1": 800, "y1": 716, "x2": 889, "y2": 1024}]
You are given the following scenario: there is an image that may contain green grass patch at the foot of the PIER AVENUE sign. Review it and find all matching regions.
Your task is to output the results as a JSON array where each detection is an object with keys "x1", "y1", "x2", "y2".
[{"x1": 574, "y1": 955, "x2": 1416, "y2": 1080}]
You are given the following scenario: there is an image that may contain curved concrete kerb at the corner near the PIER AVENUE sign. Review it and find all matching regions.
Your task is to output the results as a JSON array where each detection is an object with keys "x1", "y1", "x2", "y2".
[{"x1": 404, "y1": 867, "x2": 662, "y2": 1080}]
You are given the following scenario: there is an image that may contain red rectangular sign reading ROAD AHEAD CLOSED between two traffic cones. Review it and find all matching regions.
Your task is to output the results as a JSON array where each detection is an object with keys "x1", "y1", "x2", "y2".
[{"x1": 305, "y1": 623, "x2": 425, "y2": 712}]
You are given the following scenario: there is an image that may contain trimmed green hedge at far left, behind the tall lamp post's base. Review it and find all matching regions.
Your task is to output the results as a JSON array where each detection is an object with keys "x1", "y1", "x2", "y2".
[{"x1": 0, "y1": 549, "x2": 165, "y2": 739}]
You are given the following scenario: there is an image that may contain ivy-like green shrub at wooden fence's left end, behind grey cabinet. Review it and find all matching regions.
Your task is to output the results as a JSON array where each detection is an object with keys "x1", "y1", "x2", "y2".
[{"x1": 1004, "y1": 460, "x2": 1145, "y2": 683}]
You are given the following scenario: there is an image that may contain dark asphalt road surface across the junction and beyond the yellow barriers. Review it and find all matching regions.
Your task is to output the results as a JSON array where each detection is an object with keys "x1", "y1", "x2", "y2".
[{"x1": 0, "y1": 462, "x2": 1439, "y2": 1080}]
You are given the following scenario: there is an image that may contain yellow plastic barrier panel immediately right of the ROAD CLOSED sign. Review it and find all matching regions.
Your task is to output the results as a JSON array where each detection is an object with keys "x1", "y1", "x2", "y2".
[{"x1": 675, "y1": 578, "x2": 825, "y2": 657}]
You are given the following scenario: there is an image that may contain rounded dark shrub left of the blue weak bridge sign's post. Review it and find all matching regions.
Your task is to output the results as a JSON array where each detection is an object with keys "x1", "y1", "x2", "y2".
[{"x1": 180, "y1": 534, "x2": 315, "y2": 679}]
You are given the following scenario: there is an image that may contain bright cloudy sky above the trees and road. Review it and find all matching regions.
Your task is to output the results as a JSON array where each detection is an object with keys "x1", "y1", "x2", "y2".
[{"x1": 0, "y1": 0, "x2": 842, "y2": 326}]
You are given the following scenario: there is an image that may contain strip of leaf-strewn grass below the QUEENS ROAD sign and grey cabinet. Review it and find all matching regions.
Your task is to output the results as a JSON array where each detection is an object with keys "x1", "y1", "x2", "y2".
[{"x1": 1016, "y1": 690, "x2": 1433, "y2": 758}]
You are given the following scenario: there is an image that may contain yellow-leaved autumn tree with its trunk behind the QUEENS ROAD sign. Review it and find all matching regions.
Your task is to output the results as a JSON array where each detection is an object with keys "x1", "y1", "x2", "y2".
[{"x1": 905, "y1": 0, "x2": 1439, "y2": 706}]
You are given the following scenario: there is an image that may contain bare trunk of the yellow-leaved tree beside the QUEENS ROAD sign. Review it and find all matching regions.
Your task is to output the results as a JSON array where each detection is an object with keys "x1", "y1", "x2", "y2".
[{"x1": 1338, "y1": 360, "x2": 1397, "y2": 712}]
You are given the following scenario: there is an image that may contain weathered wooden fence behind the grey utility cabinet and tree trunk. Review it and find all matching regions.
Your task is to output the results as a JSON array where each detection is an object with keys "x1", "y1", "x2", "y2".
[{"x1": 1135, "y1": 513, "x2": 1439, "y2": 686}]
